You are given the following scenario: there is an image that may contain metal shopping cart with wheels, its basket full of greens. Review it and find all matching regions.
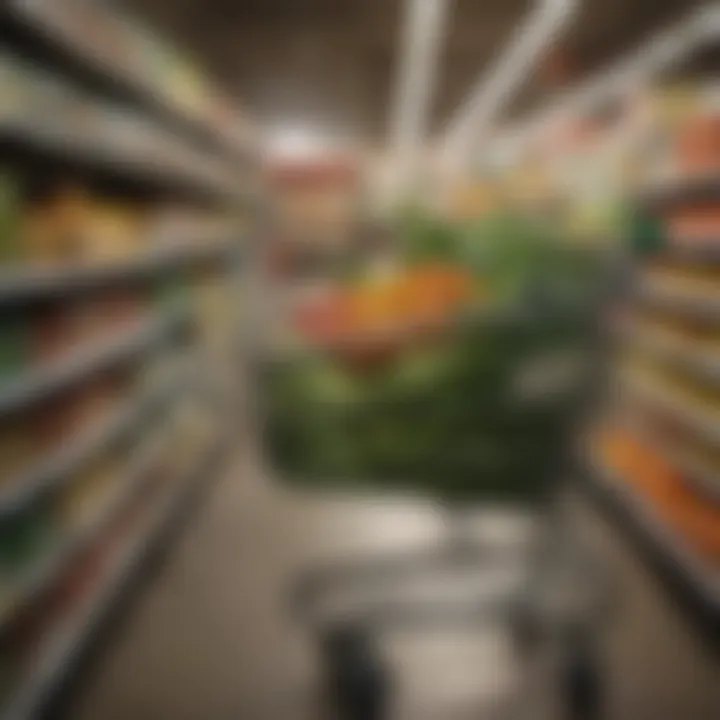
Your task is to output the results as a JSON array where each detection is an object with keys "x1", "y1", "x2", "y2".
[{"x1": 264, "y1": 286, "x2": 602, "y2": 720}]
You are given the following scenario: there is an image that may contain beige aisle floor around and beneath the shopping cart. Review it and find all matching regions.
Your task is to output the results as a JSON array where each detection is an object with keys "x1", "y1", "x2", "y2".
[{"x1": 68, "y1": 452, "x2": 720, "y2": 720}]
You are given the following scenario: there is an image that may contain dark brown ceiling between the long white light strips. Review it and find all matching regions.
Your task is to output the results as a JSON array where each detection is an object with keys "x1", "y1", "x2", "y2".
[{"x1": 121, "y1": 0, "x2": 703, "y2": 147}]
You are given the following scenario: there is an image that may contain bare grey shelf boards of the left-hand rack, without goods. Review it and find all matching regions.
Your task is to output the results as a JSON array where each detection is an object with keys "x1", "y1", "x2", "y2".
[{"x1": 0, "y1": 0, "x2": 262, "y2": 720}]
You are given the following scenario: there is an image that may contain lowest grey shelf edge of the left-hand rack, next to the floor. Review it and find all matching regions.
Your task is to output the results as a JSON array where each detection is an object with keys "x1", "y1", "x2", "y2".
[{"x1": 1, "y1": 434, "x2": 227, "y2": 720}]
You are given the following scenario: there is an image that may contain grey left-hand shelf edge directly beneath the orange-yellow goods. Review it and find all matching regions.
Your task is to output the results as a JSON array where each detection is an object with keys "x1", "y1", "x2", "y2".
[{"x1": 0, "y1": 242, "x2": 239, "y2": 305}]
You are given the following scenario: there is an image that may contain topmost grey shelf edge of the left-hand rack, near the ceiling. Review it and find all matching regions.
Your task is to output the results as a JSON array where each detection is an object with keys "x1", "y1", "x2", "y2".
[{"x1": 2, "y1": 0, "x2": 257, "y2": 165}]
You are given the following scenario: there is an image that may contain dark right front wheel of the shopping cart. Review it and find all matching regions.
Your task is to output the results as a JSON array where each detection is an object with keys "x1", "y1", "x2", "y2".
[{"x1": 561, "y1": 631, "x2": 605, "y2": 720}]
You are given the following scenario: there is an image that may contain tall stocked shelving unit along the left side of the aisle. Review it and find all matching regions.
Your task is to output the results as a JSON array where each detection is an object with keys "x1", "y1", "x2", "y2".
[{"x1": 0, "y1": 0, "x2": 262, "y2": 720}]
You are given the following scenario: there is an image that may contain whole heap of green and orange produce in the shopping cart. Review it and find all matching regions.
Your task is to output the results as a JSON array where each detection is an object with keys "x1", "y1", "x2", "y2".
[{"x1": 266, "y1": 214, "x2": 593, "y2": 499}]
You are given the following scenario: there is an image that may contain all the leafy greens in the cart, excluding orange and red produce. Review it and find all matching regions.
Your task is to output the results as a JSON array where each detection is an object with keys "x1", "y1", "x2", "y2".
[{"x1": 267, "y1": 211, "x2": 596, "y2": 498}]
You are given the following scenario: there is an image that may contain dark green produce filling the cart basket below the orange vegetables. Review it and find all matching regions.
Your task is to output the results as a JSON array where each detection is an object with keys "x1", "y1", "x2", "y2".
[{"x1": 266, "y1": 304, "x2": 584, "y2": 498}]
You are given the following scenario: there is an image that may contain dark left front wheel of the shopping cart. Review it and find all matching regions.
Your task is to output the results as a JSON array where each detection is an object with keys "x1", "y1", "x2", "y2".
[{"x1": 322, "y1": 623, "x2": 390, "y2": 720}]
